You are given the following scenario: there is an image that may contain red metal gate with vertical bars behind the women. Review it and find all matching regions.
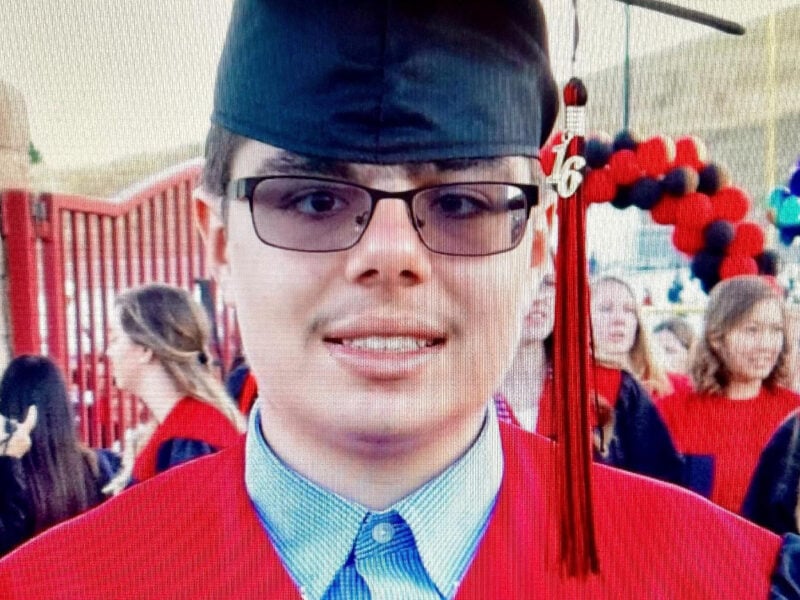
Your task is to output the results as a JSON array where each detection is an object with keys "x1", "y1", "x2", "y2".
[{"x1": 0, "y1": 161, "x2": 238, "y2": 447}]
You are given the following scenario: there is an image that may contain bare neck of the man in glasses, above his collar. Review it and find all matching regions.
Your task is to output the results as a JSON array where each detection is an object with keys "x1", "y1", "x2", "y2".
[{"x1": 261, "y1": 403, "x2": 486, "y2": 511}]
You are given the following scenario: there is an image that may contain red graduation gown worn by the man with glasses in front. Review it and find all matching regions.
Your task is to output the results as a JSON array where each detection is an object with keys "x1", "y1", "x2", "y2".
[{"x1": 0, "y1": 424, "x2": 780, "y2": 600}]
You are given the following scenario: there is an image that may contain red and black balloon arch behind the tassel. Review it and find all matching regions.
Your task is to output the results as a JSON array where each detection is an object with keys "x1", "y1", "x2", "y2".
[{"x1": 541, "y1": 131, "x2": 780, "y2": 292}]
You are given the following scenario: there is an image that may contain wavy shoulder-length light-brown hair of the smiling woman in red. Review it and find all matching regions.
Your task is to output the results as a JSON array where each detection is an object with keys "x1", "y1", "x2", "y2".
[{"x1": 689, "y1": 275, "x2": 792, "y2": 394}]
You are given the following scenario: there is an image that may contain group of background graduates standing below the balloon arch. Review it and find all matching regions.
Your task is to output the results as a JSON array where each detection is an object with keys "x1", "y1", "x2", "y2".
[{"x1": 504, "y1": 276, "x2": 800, "y2": 533}]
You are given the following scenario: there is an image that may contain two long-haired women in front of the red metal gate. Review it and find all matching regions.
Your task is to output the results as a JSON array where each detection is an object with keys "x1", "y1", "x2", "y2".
[{"x1": 0, "y1": 284, "x2": 244, "y2": 555}]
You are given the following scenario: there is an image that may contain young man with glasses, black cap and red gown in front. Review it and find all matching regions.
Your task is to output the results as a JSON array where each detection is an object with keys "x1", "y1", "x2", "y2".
[{"x1": 0, "y1": 0, "x2": 800, "y2": 600}]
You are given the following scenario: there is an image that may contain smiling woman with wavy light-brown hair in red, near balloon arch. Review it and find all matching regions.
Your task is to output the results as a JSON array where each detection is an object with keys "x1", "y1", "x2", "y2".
[{"x1": 658, "y1": 275, "x2": 800, "y2": 512}]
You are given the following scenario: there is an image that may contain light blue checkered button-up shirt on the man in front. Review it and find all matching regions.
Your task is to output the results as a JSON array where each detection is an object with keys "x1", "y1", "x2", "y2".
[{"x1": 245, "y1": 408, "x2": 503, "y2": 600}]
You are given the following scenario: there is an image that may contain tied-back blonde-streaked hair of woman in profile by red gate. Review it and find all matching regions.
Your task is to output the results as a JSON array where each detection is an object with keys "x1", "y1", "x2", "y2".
[{"x1": 116, "y1": 283, "x2": 245, "y2": 431}]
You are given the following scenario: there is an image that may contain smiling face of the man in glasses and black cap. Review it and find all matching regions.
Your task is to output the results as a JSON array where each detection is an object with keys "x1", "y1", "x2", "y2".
[{"x1": 205, "y1": 141, "x2": 538, "y2": 458}]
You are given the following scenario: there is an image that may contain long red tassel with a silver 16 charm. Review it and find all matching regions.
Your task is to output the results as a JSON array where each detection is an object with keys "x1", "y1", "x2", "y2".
[{"x1": 553, "y1": 78, "x2": 599, "y2": 577}]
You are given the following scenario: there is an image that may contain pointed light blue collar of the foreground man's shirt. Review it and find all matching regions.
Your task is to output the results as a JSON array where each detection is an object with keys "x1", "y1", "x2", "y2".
[{"x1": 245, "y1": 406, "x2": 503, "y2": 598}]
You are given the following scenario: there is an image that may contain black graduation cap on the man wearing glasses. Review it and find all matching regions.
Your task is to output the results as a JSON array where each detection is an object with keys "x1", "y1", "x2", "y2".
[{"x1": 212, "y1": 0, "x2": 558, "y2": 164}]
